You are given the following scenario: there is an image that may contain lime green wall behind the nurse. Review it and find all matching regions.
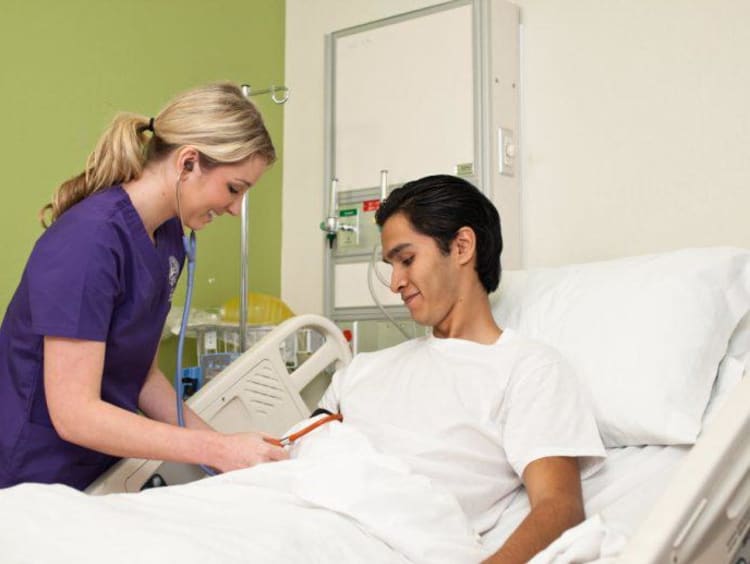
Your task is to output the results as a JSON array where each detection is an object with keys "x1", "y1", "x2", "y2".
[{"x1": 0, "y1": 0, "x2": 285, "y2": 374}]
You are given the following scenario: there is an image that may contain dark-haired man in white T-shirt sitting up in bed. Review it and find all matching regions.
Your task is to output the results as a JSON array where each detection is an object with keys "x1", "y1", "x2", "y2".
[{"x1": 320, "y1": 176, "x2": 604, "y2": 562}]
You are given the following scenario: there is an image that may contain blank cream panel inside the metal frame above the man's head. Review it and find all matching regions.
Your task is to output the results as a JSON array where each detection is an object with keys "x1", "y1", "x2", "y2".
[{"x1": 333, "y1": 4, "x2": 474, "y2": 191}]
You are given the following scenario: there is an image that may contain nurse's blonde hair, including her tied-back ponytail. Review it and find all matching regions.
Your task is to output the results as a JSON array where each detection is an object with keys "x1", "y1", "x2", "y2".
[{"x1": 39, "y1": 83, "x2": 276, "y2": 227}]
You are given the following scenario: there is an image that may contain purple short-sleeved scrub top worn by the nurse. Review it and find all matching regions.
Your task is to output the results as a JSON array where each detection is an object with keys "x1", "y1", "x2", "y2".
[{"x1": 0, "y1": 186, "x2": 185, "y2": 489}]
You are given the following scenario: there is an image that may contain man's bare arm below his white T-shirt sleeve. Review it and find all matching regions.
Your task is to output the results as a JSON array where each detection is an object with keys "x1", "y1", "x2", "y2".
[{"x1": 486, "y1": 456, "x2": 585, "y2": 564}]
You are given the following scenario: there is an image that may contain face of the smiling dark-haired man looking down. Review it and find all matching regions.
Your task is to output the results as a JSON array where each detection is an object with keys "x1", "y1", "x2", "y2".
[{"x1": 380, "y1": 213, "x2": 459, "y2": 327}]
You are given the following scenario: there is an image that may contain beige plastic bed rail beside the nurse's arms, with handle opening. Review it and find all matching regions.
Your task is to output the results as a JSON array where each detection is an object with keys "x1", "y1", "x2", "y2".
[{"x1": 86, "y1": 315, "x2": 351, "y2": 495}]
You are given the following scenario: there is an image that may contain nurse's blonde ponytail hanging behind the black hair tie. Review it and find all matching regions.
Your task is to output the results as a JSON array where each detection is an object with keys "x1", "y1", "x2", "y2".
[{"x1": 39, "y1": 113, "x2": 149, "y2": 227}]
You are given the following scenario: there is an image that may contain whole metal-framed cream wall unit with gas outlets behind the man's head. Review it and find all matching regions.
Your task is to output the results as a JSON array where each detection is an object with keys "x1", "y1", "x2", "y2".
[{"x1": 324, "y1": 0, "x2": 521, "y2": 321}]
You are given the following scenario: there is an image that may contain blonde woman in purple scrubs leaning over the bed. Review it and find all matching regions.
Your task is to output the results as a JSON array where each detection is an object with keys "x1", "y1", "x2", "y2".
[{"x1": 0, "y1": 84, "x2": 287, "y2": 489}]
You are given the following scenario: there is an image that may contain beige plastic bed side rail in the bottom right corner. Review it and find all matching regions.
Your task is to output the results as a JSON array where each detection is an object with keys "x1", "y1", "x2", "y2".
[{"x1": 617, "y1": 375, "x2": 750, "y2": 564}]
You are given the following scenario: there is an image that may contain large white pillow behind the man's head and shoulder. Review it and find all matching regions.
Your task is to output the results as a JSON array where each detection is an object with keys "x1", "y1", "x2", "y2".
[{"x1": 491, "y1": 248, "x2": 750, "y2": 447}]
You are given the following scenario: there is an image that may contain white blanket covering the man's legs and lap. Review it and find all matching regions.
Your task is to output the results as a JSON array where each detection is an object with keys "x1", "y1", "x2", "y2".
[{"x1": 0, "y1": 423, "x2": 483, "y2": 564}]
